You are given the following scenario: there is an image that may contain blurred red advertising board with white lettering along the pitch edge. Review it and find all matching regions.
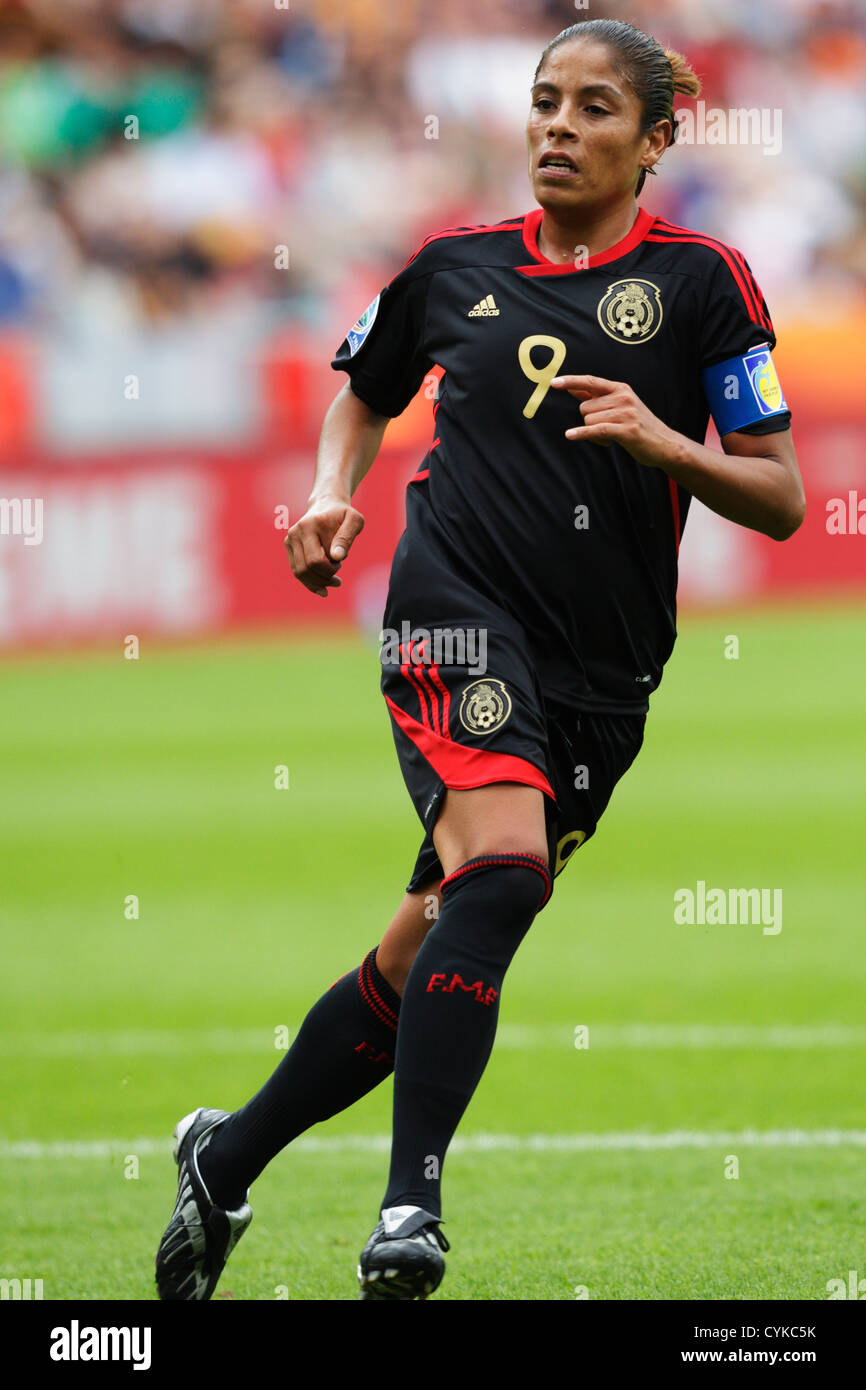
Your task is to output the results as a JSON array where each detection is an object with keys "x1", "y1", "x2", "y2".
[{"x1": 0, "y1": 424, "x2": 866, "y2": 649}]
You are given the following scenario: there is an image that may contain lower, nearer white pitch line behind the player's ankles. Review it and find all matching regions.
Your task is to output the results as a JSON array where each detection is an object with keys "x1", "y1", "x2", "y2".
[{"x1": 0, "y1": 1129, "x2": 866, "y2": 1159}]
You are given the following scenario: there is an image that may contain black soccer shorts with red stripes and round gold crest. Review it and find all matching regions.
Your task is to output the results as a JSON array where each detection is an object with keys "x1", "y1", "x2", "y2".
[{"x1": 381, "y1": 621, "x2": 646, "y2": 892}]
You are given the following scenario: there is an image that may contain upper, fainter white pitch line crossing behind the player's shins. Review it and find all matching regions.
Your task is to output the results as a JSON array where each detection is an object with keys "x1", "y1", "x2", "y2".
[{"x1": 0, "y1": 1020, "x2": 866, "y2": 1059}]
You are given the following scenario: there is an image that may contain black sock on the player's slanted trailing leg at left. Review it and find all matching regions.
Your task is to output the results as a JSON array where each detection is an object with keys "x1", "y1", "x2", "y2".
[{"x1": 200, "y1": 949, "x2": 400, "y2": 1211}]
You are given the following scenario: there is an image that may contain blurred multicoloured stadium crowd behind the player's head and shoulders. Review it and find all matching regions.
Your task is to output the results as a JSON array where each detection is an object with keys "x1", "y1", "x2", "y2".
[{"x1": 0, "y1": 0, "x2": 866, "y2": 444}]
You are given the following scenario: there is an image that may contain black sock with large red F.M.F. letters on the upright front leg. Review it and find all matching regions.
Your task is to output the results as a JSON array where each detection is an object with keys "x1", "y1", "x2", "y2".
[{"x1": 382, "y1": 853, "x2": 549, "y2": 1216}]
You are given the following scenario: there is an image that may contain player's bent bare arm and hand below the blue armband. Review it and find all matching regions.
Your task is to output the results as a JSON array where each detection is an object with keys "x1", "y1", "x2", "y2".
[{"x1": 550, "y1": 375, "x2": 806, "y2": 541}]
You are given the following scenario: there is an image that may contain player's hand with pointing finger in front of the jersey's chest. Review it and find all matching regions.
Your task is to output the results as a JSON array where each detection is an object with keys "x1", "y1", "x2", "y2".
[{"x1": 550, "y1": 377, "x2": 680, "y2": 468}]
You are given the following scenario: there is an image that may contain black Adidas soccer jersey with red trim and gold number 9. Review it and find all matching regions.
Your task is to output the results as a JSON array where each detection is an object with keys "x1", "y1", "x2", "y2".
[{"x1": 332, "y1": 209, "x2": 790, "y2": 713}]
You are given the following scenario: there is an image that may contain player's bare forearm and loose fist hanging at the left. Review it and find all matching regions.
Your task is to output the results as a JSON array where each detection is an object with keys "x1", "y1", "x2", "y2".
[{"x1": 285, "y1": 382, "x2": 391, "y2": 599}]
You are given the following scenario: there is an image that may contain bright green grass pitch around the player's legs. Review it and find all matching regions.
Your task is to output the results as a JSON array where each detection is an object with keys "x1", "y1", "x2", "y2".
[{"x1": 0, "y1": 607, "x2": 866, "y2": 1300}]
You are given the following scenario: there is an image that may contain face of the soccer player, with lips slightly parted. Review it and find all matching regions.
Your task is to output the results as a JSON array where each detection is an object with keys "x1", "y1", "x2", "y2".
[{"x1": 527, "y1": 39, "x2": 664, "y2": 213}]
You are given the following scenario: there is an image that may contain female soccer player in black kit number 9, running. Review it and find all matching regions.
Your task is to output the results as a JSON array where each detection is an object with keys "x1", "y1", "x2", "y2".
[{"x1": 157, "y1": 19, "x2": 805, "y2": 1300}]
